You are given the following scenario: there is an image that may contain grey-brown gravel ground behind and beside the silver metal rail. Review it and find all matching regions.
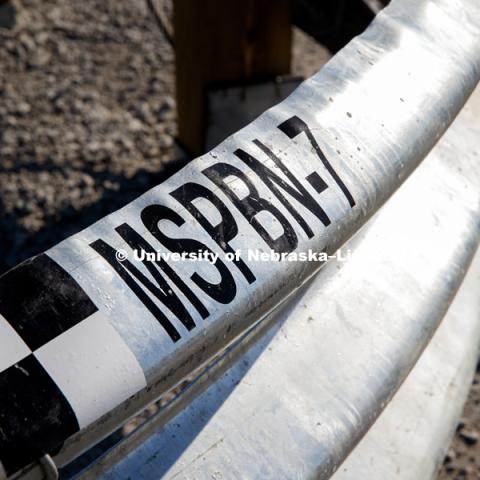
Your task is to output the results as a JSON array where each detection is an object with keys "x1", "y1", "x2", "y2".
[{"x1": 0, "y1": 0, "x2": 480, "y2": 480}]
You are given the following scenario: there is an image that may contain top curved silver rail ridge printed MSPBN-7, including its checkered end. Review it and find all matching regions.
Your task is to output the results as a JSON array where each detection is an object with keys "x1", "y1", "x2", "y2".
[{"x1": 0, "y1": 0, "x2": 480, "y2": 475}]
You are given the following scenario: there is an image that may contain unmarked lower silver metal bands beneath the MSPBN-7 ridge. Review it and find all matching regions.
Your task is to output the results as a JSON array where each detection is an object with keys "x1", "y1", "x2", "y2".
[{"x1": 75, "y1": 80, "x2": 480, "y2": 480}]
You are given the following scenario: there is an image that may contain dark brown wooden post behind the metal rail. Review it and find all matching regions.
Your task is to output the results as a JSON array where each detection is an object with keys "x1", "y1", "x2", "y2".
[{"x1": 174, "y1": 0, "x2": 291, "y2": 155}]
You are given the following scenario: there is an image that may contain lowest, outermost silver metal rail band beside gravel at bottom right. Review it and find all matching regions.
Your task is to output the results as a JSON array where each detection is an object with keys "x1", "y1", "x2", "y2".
[{"x1": 332, "y1": 251, "x2": 480, "y2": 480}]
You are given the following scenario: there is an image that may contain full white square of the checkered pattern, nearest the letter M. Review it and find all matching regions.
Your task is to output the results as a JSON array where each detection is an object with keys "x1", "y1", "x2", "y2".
[{"x1": 34, "y1": 312, "x2": 146, "y2": 428}]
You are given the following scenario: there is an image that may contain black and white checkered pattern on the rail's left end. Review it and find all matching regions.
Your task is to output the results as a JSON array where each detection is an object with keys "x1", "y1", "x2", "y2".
[{"x1": 0, "y1": 254, "x2": 146, "y2": 474}]
